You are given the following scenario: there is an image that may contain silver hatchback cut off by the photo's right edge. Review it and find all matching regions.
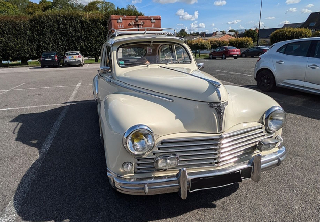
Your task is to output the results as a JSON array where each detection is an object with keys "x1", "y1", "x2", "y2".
[{"x1": 254, "y1": 37, "x2": 320, "y2": 94}]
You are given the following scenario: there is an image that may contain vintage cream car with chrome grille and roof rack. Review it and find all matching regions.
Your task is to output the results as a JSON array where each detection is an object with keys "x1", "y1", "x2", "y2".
[{"x1": 93, "y1": 30, "x2": 286, "y2": 199}]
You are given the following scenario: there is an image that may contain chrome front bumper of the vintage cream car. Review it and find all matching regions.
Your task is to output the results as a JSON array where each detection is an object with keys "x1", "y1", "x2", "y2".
[{"x1": 108, "y1": 146, "x2": 286, "y2": 199}]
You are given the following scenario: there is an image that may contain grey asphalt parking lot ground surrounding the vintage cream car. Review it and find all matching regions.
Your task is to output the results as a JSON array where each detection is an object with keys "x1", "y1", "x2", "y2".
[{"x1": 0, "y1": 58, "x2": 320, "y2": 222}]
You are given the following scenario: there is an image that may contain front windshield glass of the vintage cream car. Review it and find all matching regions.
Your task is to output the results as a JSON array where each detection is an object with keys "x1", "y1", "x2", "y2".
[{"x1": 117, "y1": 42, "x2": 191, "y2": 68}]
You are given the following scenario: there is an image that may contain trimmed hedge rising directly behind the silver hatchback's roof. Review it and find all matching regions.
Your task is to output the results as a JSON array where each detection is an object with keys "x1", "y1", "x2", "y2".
[{"x1": 270, "y1": 28, "x2": 312, "y2": 44}]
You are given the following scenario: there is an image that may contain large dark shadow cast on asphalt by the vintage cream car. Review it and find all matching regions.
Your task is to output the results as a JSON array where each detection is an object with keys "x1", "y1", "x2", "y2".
[{"x1": 11, "y1": 101, "x2": 239, "y2": 222}]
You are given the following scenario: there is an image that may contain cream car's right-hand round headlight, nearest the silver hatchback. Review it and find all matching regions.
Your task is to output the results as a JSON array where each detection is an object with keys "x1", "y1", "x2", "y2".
[{"x1": 265, "y1": 106, "x2": 286, "y2": 133}]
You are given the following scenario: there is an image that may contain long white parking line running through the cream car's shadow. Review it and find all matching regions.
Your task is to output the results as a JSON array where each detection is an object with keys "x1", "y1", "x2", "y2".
[{"x1": 0, "y1": 81, "x2": 81, "y2": 222}]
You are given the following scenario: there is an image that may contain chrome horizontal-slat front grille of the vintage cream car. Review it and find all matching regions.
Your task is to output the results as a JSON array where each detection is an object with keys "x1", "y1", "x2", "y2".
[{"x1": 135, "y1": 126, "x2": 271, "y2": 173}]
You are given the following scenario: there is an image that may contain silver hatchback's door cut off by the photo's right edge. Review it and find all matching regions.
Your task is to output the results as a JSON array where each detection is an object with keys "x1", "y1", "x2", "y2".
[{"x1": 305, "y1": 41, "x2": 320, "y2": 90}]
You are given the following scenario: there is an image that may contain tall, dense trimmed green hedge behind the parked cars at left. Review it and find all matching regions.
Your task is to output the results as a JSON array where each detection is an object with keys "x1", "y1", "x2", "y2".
[{"x1": 0, "y1": 9, "x2": 142, "y2": 62}]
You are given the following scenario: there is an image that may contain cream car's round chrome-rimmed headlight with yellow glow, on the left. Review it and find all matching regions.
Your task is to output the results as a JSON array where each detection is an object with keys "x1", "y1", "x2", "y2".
[{"x1": 123, "y1": 124, "x2": 154, "y2": 156}]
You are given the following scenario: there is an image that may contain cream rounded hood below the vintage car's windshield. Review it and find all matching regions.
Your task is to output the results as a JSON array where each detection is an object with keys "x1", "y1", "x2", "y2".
[{"x1": 118, "y1": 67, "x2": 227, "y2": 102}]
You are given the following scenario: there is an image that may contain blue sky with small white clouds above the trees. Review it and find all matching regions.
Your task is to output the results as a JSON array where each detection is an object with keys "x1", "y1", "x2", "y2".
[{"x1": 34, "y1": 0, "x2": 320, "y2": 32}]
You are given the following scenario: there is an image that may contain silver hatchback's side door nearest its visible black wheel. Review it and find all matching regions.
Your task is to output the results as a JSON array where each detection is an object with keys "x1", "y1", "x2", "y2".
[{"x1": 273, "y1": 41, "x2": 311, "y2": 87}]
